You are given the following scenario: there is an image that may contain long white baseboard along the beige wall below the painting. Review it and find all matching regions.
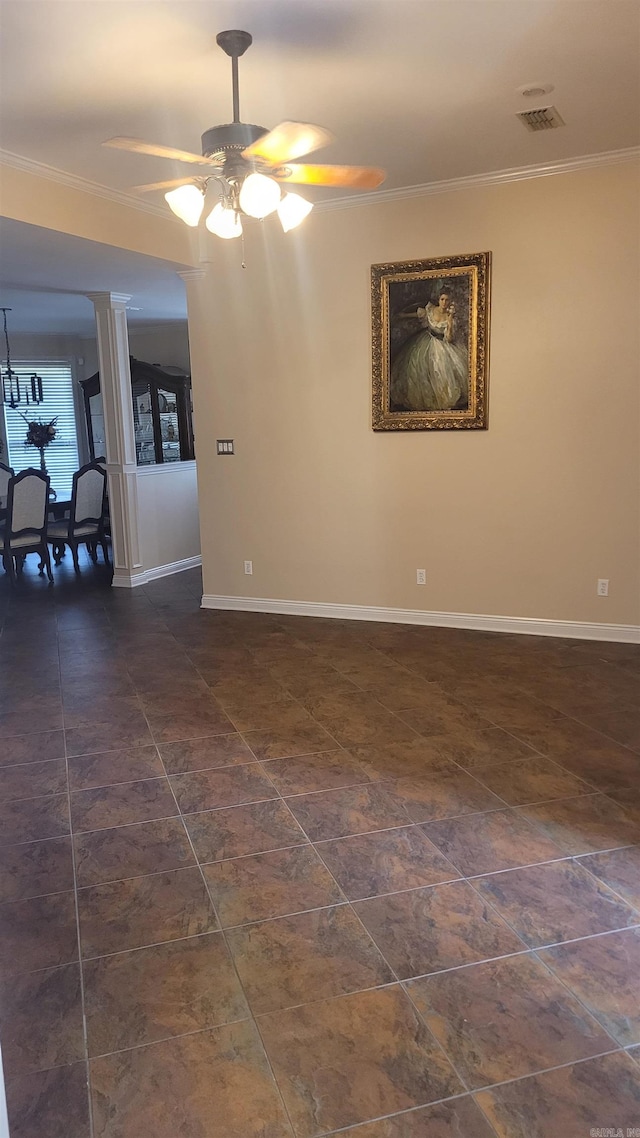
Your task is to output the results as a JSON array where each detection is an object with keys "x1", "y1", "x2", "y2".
[{"x1": 202, "y1": 594, "x2": 640, "y2": 644}]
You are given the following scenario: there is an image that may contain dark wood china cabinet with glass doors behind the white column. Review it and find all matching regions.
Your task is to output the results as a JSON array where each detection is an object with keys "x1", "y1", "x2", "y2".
[{"x1": 81, "y1": 356, "x2": 194, "y2": 467}]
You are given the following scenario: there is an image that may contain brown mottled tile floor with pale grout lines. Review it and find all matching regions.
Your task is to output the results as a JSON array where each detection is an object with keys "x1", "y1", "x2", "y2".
[{"x1": 0, "y1": 550, "x2": 640, "y2": 1138}]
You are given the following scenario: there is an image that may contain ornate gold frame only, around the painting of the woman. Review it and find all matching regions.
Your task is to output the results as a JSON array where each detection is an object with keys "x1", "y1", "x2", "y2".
[{"x1": 371, "y1": 253, "x2": 491, "y2": 430}]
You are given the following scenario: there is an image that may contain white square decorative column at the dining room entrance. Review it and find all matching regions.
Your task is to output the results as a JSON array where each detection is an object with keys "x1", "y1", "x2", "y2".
[{"x1": 87, "y1": 292, "x2": 142, "y2": 588}]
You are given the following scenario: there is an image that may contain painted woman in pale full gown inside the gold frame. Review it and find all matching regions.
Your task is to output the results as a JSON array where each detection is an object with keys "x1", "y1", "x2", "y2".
[{"x1": 389, "y1": 285, "x2": 469, "y2": 411}]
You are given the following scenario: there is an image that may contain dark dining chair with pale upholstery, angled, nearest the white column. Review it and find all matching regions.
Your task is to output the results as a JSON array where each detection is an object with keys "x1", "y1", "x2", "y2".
[{"x1": 47, "y1": 461, "x2": 109, "y2": 572}]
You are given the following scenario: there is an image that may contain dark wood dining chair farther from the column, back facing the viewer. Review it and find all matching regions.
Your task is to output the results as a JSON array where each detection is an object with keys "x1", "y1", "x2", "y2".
[{"x1": 2, "y1": 468, "x2": 54, "y2": 585}]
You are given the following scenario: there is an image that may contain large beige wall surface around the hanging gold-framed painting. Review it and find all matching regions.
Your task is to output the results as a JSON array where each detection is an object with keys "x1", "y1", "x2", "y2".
[{"x1": 141, "y1": 164, "x2": 640, "y2": 624}]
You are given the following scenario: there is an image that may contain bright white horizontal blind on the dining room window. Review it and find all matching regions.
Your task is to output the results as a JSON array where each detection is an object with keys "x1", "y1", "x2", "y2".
[{"x1": 5, "y1": 360, "x2": 80, "y2": 498}]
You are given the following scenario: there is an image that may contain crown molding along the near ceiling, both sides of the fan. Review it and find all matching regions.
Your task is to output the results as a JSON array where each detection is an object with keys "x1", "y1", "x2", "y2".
[{"x1": 0, "y1": 147, "x2": 640, "y2": 221}]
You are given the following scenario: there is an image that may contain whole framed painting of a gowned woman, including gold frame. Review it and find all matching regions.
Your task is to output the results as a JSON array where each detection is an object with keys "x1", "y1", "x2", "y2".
[{"x1": 371, "y1": 253, "x2": 491, "y2": 430}]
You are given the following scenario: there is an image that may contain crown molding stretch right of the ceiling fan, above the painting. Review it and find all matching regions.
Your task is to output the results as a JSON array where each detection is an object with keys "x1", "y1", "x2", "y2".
[{"x1": 315, "y1": 146, "x2": 640, "y2": 213}]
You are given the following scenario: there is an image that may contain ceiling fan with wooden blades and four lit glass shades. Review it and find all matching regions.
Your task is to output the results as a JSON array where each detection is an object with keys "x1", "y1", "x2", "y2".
[{"x1": 102, "y1": 30, "x2": 385, "y2": 238}]
